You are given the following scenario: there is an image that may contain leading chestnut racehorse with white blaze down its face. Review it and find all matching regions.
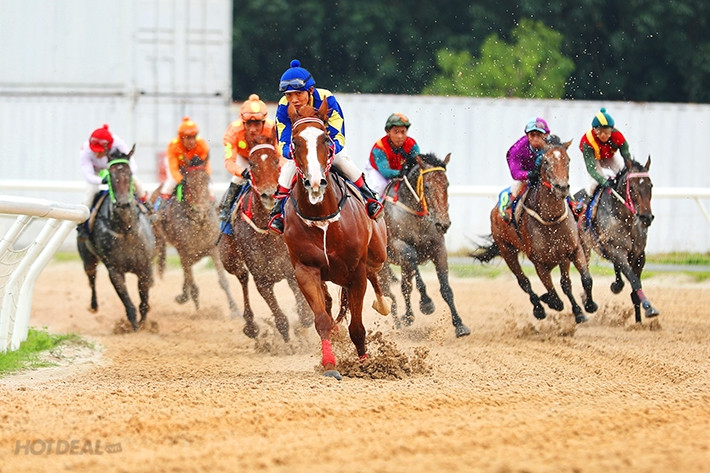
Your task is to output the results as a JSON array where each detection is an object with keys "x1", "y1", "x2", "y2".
[{"x1": 283, "y1": 101, "x2": 390, "y2": 379}]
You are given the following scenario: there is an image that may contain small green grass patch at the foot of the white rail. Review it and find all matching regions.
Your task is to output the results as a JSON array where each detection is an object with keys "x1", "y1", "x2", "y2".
[{"x1": 0, "y1": 327, "x2": 81, "y2": 377}]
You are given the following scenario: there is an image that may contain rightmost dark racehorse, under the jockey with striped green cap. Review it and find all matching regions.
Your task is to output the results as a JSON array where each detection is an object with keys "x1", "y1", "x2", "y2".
[{"x1": 579, "y1": 156, "x2": 659, "y2": 323}]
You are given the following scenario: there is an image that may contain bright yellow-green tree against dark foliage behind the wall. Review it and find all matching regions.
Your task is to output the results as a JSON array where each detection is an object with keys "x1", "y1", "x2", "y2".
[{"x1": 424, "y1": 19, "x2": 574, "y2": 98}]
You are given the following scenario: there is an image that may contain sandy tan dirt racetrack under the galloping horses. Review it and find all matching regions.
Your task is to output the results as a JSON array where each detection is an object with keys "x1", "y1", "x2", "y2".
[{"x1": 0, "y1": 262, "x2": 710, "y2": 473}]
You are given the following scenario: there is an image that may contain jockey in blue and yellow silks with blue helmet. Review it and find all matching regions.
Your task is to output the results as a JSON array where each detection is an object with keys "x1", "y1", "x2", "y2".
[{"x1": 269, "y1": 59, "x2": 390, "y2": 234}]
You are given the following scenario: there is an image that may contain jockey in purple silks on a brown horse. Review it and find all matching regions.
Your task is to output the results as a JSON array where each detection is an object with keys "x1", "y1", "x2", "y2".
[{"x1": 498, "y1": 117, "x2": 550, "y2": 222}]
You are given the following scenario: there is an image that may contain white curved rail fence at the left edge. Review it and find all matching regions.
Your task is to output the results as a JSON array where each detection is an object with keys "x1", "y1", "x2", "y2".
[{"x1": 0, "y1": 195, "x2": 89, "y2": 353}]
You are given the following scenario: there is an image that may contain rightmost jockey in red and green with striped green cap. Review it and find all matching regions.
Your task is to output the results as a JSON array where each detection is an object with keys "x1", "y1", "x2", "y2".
[{"x1": 574, "y1": 108, "x2": 633, "y2": 215}]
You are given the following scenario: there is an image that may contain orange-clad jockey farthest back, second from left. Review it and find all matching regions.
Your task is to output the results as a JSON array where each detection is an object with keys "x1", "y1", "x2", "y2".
[{"x1": 154, "y1": 117, "x2": 212, "y2": 211}]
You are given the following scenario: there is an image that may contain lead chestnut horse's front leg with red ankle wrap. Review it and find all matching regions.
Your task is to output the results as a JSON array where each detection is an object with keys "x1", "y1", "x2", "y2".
[{"x1": 292, "y1": 266, "x2": 343, "y2": 380}]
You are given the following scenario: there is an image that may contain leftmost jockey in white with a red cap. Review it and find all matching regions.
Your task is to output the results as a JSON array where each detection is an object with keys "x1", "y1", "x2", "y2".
[{"x1": 76, "y1": 125, "x2": 148, "y2": 238}]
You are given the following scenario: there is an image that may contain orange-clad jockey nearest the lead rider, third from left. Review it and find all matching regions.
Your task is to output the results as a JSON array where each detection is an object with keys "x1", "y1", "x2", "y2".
[{"x1": 219, "y1": 94, "x2": 276, "y2": 222}]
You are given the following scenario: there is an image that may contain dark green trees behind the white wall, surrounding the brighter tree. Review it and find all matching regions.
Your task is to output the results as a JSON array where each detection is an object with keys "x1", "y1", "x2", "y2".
[{"x1": 232, "y1": 0, "x2": 710, "y2": 103}]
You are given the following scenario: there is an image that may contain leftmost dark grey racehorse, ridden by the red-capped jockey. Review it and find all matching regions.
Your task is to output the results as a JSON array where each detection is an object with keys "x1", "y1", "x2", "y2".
[{"x1": 77, "y1": 145, "x2": 155, "y2": 331}]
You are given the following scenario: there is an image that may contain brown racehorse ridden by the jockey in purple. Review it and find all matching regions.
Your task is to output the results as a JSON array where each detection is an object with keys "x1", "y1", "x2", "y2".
[{"x1": 471, "y1": 135, "x2": 597, "y2": 323}]
